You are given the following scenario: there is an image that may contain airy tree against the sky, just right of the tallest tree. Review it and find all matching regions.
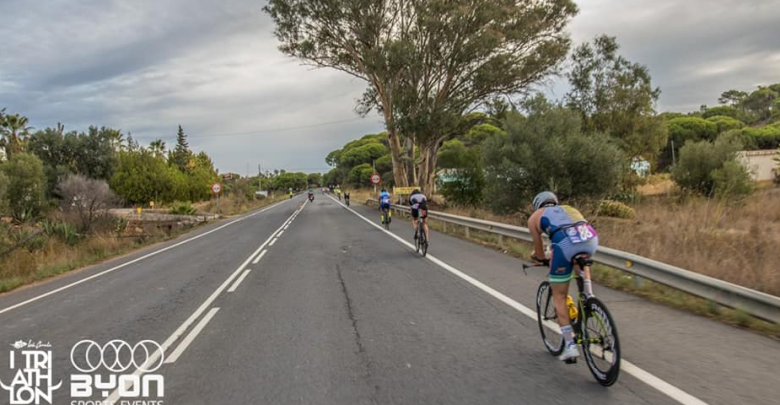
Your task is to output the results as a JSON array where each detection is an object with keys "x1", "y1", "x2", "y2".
[{"x1": 566, "y1": 35, "x2": 667, "y2": 161}]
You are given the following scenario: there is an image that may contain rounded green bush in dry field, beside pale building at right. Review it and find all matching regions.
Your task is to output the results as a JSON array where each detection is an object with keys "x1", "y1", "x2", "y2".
[{"x1": 672, "y1": 136, "x2": 750, "y2": 197}]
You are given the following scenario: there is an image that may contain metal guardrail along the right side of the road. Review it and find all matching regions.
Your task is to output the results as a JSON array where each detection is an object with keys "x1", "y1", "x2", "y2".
[{"x1": 366, "y1": 199, "x2": 780, "y2": 323}]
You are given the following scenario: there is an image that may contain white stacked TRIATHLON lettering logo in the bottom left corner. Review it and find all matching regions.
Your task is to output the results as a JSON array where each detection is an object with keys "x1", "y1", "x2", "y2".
[{"x1": 0, "y1": 340, "x2": 62, "y2": 405}]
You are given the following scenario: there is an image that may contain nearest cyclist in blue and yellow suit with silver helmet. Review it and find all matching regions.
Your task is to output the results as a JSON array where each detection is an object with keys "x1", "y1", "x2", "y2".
[{"x1": 528, "y1": 191, "x2": 599, "y2": 360}]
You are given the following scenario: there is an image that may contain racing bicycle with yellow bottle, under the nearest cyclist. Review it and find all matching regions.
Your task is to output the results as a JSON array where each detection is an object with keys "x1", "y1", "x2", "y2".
[{"x1": 523, "y1": 254, "x2": 620, "y2": 387}]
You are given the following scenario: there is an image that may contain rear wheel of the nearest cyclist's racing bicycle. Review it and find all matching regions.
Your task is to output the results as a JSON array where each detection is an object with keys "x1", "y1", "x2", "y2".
[{"x1": 581, "y1": 297, "x2": 620, "y2": 387}]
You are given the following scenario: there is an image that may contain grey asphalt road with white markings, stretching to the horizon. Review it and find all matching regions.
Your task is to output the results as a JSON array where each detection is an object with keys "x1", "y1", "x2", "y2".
[{"x1": 0, "y1": 194, "x2": 780, "y2": 405}]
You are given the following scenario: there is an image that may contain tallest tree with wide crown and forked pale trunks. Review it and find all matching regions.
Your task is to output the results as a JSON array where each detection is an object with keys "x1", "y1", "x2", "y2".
[{"x1": 264, "y1": 0, "x2": 577, "y2": 193}]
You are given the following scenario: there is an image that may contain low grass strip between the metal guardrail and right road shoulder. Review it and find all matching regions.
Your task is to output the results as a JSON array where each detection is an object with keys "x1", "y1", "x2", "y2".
[{"x1": 364, "y1": 197, "x2": 780, "y2": 339}]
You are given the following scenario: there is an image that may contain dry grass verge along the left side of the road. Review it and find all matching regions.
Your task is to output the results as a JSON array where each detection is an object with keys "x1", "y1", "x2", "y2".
[{"x1": 0, "y1": 193, "x2": 285, "y2": 293}]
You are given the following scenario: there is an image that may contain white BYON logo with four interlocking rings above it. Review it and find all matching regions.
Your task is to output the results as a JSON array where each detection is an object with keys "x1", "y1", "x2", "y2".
[{"x1": 70, "y1": 339, "x2": 165, "y2": 405}]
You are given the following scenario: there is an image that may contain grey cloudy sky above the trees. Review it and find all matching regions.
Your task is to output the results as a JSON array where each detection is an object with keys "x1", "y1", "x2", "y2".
[{"x1": 0, "y1": 0, "x2": 780, "y2": 173}]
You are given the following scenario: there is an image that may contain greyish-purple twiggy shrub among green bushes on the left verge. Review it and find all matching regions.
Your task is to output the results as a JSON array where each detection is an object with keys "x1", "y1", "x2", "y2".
[{"x1": 57, "y1": 174, "x2": 116, "y2": 233}]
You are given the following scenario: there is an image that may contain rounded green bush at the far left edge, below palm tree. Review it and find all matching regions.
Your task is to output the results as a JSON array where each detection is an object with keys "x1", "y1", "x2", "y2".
[{"x1": 0, "y1": 153, "x2": 46, "y2": 222}]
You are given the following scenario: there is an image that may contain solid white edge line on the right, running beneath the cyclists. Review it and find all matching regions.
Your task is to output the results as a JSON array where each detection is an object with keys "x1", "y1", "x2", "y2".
[{"x1": 331, "y1": 197, "x2": 708, "y2": 405}]
